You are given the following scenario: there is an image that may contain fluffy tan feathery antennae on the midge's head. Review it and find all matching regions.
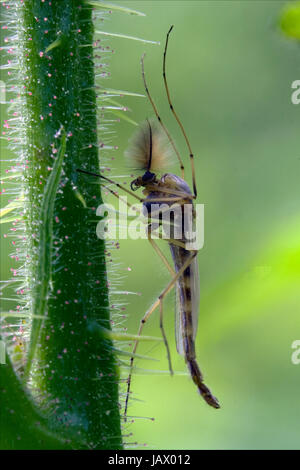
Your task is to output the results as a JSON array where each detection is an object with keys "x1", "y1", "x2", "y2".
[{"x1": 125, "y1": 118, "x2": 174, "y2": 172}]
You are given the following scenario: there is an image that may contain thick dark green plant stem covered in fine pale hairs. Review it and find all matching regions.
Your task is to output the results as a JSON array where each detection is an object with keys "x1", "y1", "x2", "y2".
[{"x1": 12, "y1": 0, "x2": 122, "y2": 449}]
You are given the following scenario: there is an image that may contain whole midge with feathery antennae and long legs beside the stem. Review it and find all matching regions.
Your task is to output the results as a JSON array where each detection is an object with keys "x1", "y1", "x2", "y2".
[{"x1": 78, "y1": 26, "x2": 220, "y2": 421}]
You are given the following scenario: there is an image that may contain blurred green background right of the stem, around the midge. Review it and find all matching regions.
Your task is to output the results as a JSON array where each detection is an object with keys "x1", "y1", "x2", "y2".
[{"x1": 1, "y1": 0, "x2": 300, "y2": 449}]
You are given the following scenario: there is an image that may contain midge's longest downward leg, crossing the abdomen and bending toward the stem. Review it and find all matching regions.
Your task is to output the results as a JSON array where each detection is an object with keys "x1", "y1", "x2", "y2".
[{"x1": 124, "y1": 251, "x2": 197, "y2": 422}]
